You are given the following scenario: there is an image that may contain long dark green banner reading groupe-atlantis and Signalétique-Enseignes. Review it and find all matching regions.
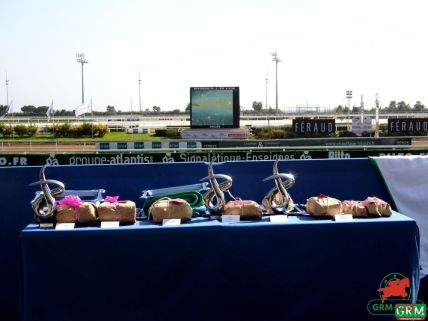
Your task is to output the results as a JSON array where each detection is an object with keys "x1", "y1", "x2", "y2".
[{"x1": 0, "y1": 148, "x2": 428, "y2": 167}]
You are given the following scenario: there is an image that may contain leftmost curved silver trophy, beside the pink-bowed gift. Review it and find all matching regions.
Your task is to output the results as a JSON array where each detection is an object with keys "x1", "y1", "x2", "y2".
[{"x1": 29, "y1": 165, "x2": 65, "y2": 220}]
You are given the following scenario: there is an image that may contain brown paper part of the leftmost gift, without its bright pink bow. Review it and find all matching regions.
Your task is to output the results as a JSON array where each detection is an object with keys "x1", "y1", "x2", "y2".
[{"x1": 55, "y1": 202, "x2": 97, "y2": 225}]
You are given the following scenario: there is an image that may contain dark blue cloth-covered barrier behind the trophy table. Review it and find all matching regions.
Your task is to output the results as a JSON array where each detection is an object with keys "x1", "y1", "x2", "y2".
[{"x1": 0, "y1": 159, "x2": 398, "y2": 321}]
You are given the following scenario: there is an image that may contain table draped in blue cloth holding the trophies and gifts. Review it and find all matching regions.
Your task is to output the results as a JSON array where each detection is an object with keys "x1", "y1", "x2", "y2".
[{"x1": 20, "y1": 212, "x2": 419, "y2": 321}]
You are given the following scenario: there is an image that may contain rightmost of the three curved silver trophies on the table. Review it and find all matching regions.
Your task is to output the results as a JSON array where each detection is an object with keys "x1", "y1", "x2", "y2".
[{"x1": 262, "y1": 160, "x2": 295, "y2": 214}]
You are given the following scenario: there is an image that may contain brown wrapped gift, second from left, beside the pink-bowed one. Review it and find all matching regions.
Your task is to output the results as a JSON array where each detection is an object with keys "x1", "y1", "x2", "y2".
[{"x1": 97, "y1": 201, "x2": 137, "y2": 224}]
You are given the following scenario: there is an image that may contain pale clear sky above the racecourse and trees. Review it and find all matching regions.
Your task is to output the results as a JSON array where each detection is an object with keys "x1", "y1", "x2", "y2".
[{"x1": 0, "y1": 0, "x2": 428, "y2": 111}]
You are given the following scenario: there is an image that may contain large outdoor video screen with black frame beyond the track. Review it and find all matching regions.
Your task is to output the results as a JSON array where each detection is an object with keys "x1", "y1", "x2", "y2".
[{"x1": 190, "y1": 87, "x2": 239, "y2": 128}]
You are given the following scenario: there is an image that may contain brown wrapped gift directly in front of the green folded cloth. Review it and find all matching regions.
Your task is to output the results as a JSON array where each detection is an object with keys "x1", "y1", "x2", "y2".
[{"x1": 149, "y1": 198, "x2": 193, "y2": 223}]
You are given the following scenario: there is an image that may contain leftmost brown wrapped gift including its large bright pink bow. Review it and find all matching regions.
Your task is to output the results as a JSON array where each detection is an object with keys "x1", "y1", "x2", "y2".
[{"x1": 55, "y1": 195, "x2": 97, "y2": 225}]
